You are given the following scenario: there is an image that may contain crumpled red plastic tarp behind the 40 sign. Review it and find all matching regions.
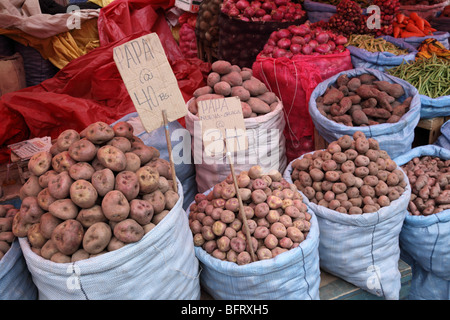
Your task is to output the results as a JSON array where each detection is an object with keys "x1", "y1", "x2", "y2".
[{"x1": 0, "y1": 0, "x2": 210, "y2": 163}]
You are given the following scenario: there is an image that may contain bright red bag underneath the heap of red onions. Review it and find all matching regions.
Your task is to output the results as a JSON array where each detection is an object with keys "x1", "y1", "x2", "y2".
[{"x1": 252, "y1": 50, "x2": 352, "y2": 162}]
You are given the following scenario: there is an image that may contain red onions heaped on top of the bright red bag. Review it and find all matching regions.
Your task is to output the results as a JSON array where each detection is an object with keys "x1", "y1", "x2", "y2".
[{"x1": 261, "y1": 23, "x2": 347, "y2": 59}]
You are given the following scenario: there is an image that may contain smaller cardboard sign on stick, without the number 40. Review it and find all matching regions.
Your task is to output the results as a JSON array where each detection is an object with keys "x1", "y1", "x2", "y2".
[{"x1": 197, "y1": 97, "x2": 248, "y2": 153}]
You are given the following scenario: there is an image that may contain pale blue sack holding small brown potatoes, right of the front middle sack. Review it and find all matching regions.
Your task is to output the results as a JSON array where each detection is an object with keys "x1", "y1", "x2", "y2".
[{"x1": 283, "y1": 157, "x2": 411, "y2": 300}]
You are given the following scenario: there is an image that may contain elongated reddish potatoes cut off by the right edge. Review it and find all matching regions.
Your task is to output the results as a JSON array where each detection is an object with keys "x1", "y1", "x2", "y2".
[{"x1": 402, "y1": 156, "x2": 450, "y2": 216}]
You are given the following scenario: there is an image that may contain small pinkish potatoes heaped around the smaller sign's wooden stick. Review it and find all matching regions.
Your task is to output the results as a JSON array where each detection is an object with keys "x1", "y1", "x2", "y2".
[{"x1": 189, "y1": 165, "x2": 311, "y2": 265}]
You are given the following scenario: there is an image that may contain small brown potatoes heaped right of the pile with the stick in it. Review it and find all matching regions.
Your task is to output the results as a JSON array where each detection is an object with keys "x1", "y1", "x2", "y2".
[{"x1": 291, "y1": 131, "x2": 407, "y2": 214}]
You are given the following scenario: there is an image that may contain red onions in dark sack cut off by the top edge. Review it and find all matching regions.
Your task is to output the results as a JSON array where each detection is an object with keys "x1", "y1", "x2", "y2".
[{"x1": 221, "y1": 0, "x2": 305, "y2": 22}]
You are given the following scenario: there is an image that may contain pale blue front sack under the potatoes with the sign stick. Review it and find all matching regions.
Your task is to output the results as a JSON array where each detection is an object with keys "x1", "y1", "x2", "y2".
[{"x1": 187, "y1": 188, "x2": 320, "y2": 300}]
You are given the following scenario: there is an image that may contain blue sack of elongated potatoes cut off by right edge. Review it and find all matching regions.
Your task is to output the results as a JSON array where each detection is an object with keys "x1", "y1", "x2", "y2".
[{"x1": 394, "y1": 145, "x2": 450, "y2": 300}]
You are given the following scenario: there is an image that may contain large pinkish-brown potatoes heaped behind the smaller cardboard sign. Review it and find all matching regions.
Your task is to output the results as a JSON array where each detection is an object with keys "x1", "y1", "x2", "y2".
[{"x1": 188, "y1": 60, "x2": 279, "y2": 118}]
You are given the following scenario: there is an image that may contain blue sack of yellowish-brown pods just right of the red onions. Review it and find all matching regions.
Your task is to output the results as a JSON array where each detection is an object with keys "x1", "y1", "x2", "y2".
[{"x1": 346, "y1": 34, "x2": 417, "y2": 71}]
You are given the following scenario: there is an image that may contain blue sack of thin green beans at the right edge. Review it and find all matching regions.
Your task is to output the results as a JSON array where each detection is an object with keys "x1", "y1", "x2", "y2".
[{"x1": 387, "y1": 55, "x2": 450, "y2": 119}]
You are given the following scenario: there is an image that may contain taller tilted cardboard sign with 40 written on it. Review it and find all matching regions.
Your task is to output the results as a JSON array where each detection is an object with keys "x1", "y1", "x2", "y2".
[{"x1": 114, "y1": 33, "x2": 187, "y2": 132}]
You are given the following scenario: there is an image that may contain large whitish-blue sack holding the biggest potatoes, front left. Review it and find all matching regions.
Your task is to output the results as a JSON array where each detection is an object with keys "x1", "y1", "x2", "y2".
[{"x1": 19, "y1": 181, "x2": 200, "y2": 300}]
